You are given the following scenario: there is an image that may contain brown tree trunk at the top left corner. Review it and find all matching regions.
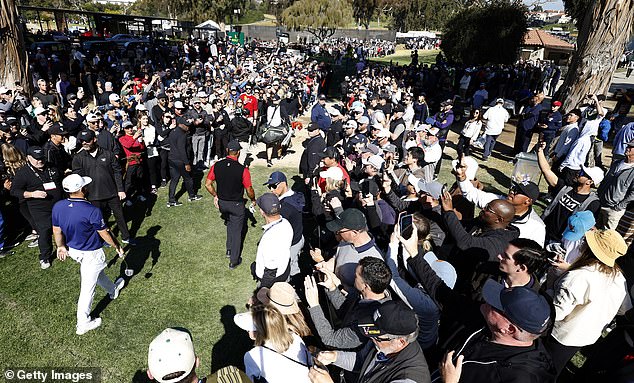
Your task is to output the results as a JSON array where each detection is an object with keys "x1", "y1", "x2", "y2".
[{"x1": 0, "y1": 0, "x2": 32, "y2": 95}]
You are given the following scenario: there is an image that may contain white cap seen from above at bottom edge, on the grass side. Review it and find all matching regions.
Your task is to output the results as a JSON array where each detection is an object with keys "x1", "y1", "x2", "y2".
[{"x1": 147, "y1": 328, "x2": 196, "y2": 383}]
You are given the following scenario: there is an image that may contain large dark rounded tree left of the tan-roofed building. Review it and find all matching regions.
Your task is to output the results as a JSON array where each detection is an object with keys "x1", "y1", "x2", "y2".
[{"x1": 441, "y1": 1, "x2": 528, "y2": 64}]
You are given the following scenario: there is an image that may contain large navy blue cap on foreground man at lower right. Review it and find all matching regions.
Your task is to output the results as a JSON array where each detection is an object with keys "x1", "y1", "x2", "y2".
[{"x1": 482, "y1": 279, "x2": 550, "y2": 334}]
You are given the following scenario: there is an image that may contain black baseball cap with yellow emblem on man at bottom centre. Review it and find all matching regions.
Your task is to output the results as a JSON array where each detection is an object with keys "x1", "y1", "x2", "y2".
[{"x1": 358, "y1": 301, "x2": 418, "y2": 338}]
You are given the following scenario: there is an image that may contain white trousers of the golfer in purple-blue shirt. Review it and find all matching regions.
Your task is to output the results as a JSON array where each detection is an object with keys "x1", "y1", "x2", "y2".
[{"x1": 68, "y1": 248, "x2": 115, "y2": 328}]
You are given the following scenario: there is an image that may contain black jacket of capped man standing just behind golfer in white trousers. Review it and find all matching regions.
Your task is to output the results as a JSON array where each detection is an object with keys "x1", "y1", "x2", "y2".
[{"x1": 73, "y1": 148, "x2": 124, "y2": 201}]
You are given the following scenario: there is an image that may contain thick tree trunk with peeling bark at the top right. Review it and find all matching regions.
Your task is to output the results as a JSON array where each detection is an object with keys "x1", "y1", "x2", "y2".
[{"x1": 558, "y1": 0, "x2": 634, "y2": 110}]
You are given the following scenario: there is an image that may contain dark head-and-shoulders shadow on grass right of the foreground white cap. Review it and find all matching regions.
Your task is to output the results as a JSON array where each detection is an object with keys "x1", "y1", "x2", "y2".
[{"x1": 211, "y1": 305, "x2": 253, "y2": 373}]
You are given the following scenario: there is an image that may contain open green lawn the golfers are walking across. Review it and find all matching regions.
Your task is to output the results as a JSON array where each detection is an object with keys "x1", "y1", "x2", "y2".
[{"x1": 0, "y1": 168, "x2": 292, "y2": 382}]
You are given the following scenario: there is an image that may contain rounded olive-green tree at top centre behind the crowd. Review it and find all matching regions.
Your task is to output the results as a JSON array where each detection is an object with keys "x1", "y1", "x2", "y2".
[{"x1": 281, "y1": 0, "x2": 352, "y2": 41}]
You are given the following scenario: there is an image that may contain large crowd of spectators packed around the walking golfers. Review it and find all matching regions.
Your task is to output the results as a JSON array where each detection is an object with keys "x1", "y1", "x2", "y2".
[{"x1": 0, "y1": 29, "x2": 634, "y2": 383}]
